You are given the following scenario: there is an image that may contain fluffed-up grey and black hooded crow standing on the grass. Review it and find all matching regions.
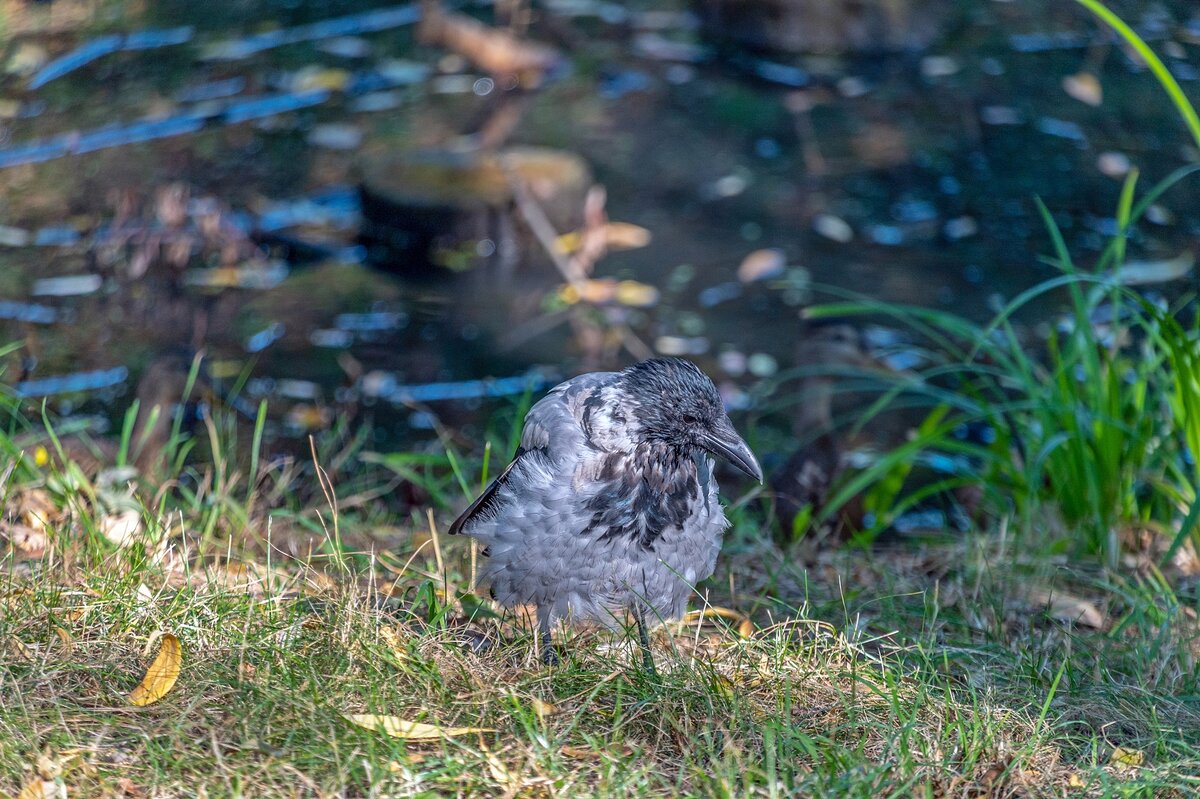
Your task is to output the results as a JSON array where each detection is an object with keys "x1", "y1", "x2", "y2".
[{"x1": 449, "y1": 358, "x2": 762, "y2": 673}]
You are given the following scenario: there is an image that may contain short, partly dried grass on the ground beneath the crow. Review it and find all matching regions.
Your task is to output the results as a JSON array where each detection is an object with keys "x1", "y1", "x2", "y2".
[{"x1": 7, "y1": 484, "x2": 1200, "y2": 797}]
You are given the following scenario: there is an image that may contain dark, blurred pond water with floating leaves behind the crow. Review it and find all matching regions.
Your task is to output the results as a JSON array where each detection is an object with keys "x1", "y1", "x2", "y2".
[{"x1": 0, "y1": 0, "x2": 1200, "y2": 460}]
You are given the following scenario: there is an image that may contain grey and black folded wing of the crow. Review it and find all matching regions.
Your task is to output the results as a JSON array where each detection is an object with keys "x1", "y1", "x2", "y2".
[{"x1": 449, "y1": 372, "x2": 617, "y2": 535}]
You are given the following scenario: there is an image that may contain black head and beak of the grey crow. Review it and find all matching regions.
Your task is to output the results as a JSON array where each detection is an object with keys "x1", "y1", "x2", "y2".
[{"x1": 620, "y1": 358, "x2": 762, "y2": 482}]
